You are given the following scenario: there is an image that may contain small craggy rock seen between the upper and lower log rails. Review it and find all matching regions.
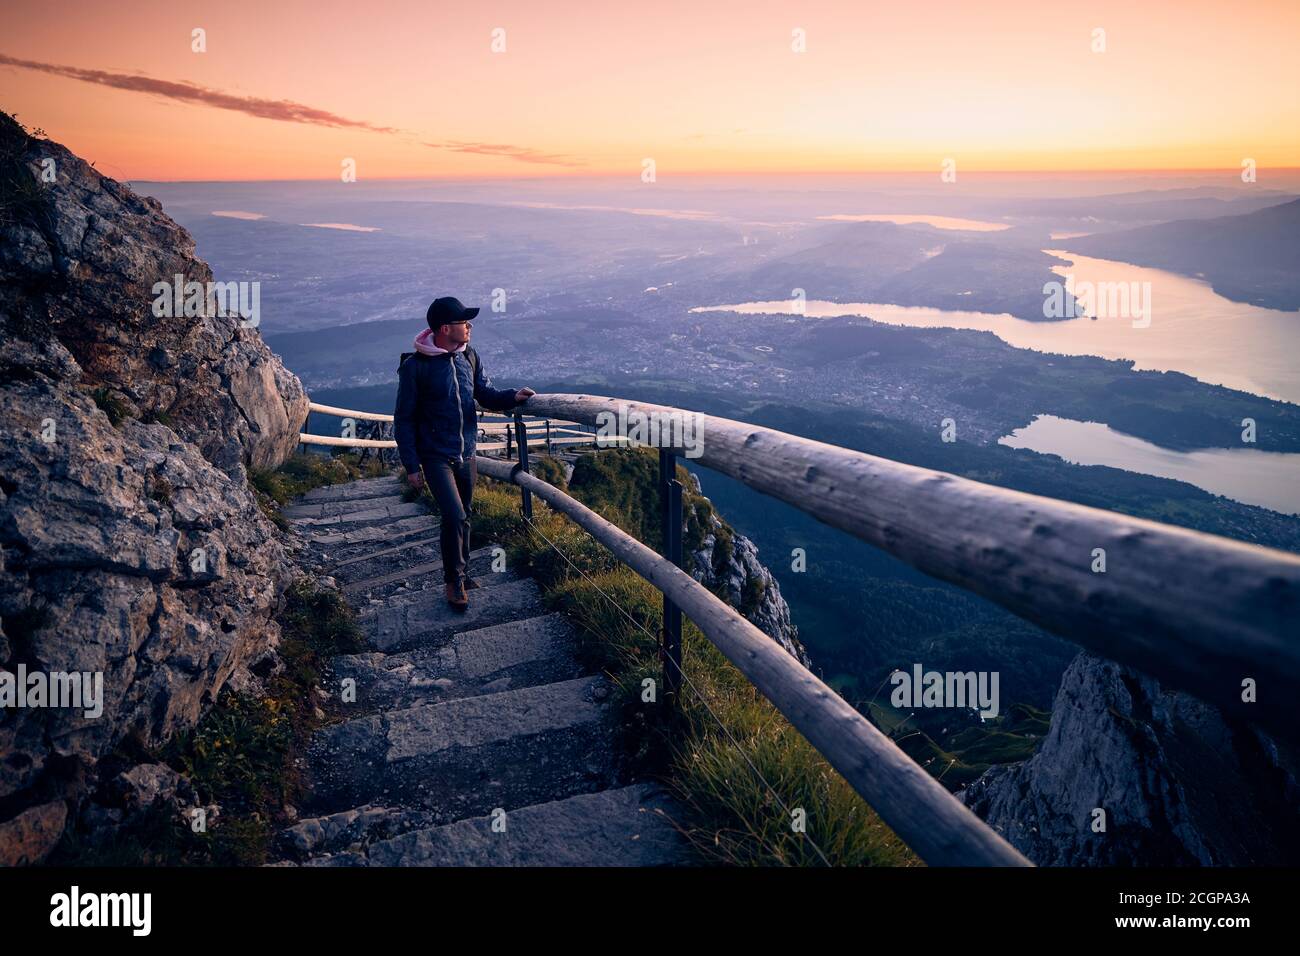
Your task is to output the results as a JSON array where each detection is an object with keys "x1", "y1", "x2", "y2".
[{"x1": 685, "y1": 472, "x2": 811, "y2": 667}]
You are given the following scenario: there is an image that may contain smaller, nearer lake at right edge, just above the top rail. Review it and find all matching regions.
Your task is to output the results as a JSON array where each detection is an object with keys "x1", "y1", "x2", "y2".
[{"x1": 998, "y1": 415, "x2": 1300, "y2": 514}]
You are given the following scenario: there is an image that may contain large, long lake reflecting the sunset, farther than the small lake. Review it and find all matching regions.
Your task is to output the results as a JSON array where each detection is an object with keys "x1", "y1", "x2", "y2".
[{"x1": 690, "y1": 250, "x2": 1300, "y2": 402}]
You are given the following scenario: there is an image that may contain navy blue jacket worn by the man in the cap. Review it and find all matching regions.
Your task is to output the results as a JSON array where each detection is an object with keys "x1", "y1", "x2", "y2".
[{"x1": 393, "y1": 346, "x2": 520, "y2": 475}]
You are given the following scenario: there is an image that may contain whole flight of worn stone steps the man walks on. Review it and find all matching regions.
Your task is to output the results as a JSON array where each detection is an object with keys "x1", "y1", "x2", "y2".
[{"x1": 281, "y1": 477, "x2": 689, "y2": 866}]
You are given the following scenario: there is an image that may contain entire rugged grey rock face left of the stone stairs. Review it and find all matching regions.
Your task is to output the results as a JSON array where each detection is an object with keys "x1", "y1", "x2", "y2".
[{"x1": 0, "y1": 114, "x2": 307, "y2": 864}]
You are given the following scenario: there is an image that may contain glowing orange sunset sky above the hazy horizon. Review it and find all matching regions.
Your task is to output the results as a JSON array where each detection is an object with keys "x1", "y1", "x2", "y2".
[{"x1": 0, "y1": 0, "x2": 1300, "y2": 182}]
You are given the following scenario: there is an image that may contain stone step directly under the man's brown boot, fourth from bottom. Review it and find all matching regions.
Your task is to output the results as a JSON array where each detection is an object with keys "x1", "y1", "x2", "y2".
[{"x1": 358, "y1": 578, "x2": 546, "y2": 653}]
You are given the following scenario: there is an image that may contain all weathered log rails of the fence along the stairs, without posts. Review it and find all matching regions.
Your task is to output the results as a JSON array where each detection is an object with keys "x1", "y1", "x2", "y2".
[{"x1": 302, "y1": 394, "x2": 1300, "y2": 865}]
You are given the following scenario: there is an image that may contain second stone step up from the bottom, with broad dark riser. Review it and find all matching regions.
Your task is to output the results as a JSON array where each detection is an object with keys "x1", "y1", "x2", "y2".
[{"x1": 307, "y1": 676, "x2": 614, "y2": 823}]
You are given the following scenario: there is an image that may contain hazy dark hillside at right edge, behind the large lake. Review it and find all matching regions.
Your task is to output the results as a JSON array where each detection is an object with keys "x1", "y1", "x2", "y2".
[{"x1": 1061, "y1": 199, "x2": 1300, "y2": 311}]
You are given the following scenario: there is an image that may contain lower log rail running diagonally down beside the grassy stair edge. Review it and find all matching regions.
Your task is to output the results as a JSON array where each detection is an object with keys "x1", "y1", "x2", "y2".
[{"x1": 476, "y1": 458, "x2": 1030, "y2": 866}]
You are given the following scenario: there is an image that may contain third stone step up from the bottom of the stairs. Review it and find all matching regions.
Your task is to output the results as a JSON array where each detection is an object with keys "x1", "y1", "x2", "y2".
[{"x1": 330, "y1": 613, "x2": 582, "y2": 710}]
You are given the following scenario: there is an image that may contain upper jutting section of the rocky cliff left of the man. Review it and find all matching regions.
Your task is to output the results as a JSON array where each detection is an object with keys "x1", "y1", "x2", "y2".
[{"x1": 0, "y1": 117, "x2": 307, "y2": 473}]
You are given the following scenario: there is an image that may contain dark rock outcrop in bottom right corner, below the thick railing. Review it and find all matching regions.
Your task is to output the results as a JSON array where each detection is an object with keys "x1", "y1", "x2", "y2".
[{"x1": 959, "y1": 654, "x2": 1300, "y2": 866}]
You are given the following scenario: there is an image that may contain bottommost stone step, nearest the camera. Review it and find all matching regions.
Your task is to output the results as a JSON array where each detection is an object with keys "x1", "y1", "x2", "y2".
[{"x1": 335, "y1": 783, "x2": 690, "y2": 866}]
